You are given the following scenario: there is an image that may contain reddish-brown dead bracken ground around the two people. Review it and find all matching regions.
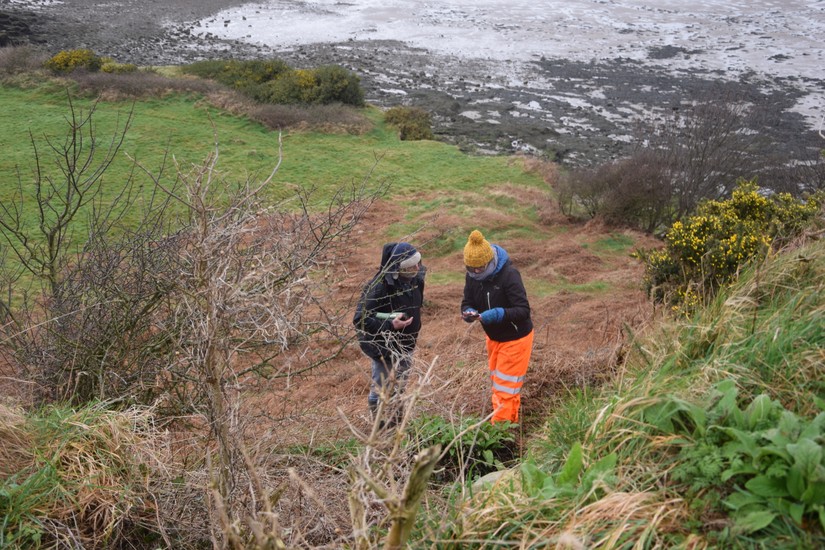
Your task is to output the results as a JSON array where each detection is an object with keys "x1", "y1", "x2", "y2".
[{"x1": 252, "y1": 185, "x2": 657, "y2": 445}]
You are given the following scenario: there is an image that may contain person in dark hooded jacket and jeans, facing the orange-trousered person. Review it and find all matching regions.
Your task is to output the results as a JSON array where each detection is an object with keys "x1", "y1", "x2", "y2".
[{"x1": 352, "y1": 242, "x2": 426, "y2": 422}]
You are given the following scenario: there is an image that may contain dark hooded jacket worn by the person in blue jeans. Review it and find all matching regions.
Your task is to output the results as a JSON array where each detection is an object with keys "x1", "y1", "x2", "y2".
[{"x1": 352, "y1": 243, "x2": 426, "y2": 360}]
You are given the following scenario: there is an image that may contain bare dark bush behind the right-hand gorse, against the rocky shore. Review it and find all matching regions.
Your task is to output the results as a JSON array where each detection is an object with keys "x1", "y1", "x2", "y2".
[{"x1": 557, "y1": 89, "x2": 773, "y2": 232}]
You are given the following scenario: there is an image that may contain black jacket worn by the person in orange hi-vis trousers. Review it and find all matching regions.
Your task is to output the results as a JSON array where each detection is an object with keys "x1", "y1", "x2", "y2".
[{"x1": 461, "y1": 244, "x2": 533, "y2": 342}]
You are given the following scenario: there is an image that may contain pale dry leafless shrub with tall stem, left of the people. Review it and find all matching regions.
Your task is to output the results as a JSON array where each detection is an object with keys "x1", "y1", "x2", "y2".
[{"x1": 127, "y1": 133, "x2": 381, "y2": 547}]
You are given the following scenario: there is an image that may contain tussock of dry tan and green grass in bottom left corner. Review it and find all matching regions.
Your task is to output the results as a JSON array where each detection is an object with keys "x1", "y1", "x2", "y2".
[{"x1": 0, "y1": 406, "x2": 182, "y2": 548}]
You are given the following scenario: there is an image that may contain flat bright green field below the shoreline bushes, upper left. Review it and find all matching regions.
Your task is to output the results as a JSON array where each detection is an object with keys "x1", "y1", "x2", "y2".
[{"x1": 0, "y1": 85, "x2": 542, "y2": 212}]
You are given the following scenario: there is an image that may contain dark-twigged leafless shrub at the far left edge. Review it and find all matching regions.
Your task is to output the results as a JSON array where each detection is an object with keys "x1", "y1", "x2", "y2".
[{"x1": 0, "y1": 98, "x2": 186, "y2": 402}]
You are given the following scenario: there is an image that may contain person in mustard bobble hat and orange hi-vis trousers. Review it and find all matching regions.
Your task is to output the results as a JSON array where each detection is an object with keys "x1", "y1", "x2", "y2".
[{"x1": 461, "y1": 230, "x2": 533, "y2": 423}]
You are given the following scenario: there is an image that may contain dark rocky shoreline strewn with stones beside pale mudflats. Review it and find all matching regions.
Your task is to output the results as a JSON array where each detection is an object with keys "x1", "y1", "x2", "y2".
[{"x1": 0, "y1": 0, "x2": 825, "y2": 165}]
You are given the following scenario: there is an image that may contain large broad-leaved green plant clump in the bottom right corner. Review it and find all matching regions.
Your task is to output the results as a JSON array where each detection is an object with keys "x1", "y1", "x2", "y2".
[{"x1": 642, "y1": 380, "x2": 825, "y2": 533}]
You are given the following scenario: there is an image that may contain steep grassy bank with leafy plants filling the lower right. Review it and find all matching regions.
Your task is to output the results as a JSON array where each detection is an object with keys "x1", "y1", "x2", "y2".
[{"x1": 432, "y1": 241, "x2": 825, "y2": 548}]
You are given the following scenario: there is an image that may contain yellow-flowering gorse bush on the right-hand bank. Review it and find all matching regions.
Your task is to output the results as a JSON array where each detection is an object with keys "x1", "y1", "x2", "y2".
[{"x1": 634, "y1": 182, "x2": 823, "y2": 313}]
